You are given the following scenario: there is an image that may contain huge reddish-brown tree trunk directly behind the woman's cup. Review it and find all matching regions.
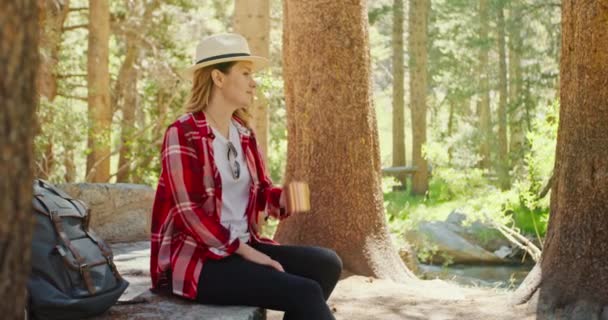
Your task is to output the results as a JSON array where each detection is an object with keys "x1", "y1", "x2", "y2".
[{"x1": 275, "y1": 0, "x2": 410, "y2": 281}]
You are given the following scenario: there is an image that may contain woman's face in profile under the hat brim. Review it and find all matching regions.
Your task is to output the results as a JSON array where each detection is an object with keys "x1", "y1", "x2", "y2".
[{"x1": 221, "y1": 61, "x2": 256, "y2": 108}]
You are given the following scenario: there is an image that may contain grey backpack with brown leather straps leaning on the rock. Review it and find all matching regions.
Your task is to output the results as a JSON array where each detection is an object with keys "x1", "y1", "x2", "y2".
[{"x1": 28, "y1": 180, "x2": 129, "y2": 320}]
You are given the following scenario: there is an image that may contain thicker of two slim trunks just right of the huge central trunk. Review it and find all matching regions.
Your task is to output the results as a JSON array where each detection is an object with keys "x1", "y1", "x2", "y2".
[{"x1": 409, "y1": 0, "x2": 430, "y2": 195}]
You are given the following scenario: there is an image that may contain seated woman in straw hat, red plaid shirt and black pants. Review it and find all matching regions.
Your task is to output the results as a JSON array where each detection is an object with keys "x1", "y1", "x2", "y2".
[{"x1": 150, "y1": 34, "x2": 342, "y2": 320}]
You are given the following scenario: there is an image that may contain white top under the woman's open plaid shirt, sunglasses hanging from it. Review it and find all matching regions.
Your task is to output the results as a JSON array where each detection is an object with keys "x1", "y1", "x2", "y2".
[{"x1": 211, "y1": 121, "x2": 251, "y2": 242}]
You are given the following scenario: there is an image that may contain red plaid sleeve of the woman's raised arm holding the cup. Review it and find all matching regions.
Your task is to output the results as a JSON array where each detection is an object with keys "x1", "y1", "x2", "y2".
[{"x1": 251, "y1": 136, "x2": 289, "y2": 220}]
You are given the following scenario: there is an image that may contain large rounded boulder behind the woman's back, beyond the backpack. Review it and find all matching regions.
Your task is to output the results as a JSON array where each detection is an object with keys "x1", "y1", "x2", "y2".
[{"x1": 58, "y1": 183, "x2": 154, "y2": 242}]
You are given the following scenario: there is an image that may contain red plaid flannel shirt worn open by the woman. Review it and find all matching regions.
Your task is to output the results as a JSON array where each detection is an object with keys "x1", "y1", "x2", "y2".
[{"x1": 150, "y1": 112, "x2": 287, "y2": 299}]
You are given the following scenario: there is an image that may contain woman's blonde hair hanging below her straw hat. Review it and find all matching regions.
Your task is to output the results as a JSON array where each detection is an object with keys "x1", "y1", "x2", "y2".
[{"x1": 185, "y1": 61, "x2": 251, "y2": 129}]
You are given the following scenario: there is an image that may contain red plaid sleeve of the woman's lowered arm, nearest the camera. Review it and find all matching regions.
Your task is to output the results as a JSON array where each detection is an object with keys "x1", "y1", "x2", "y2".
[{"x1": 162, "y1": 125, "x2": 239, "y2": 259}]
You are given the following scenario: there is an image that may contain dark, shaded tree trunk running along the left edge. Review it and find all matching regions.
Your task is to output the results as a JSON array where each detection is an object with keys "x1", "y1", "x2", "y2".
[{"x1": 0, "y1": 0, "x2": 39, "y2": 320}]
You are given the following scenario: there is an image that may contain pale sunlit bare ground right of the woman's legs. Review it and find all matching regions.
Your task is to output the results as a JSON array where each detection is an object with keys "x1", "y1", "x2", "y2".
[{"x1": 268, "y1": 276, "x2": 536, "y2": 320}]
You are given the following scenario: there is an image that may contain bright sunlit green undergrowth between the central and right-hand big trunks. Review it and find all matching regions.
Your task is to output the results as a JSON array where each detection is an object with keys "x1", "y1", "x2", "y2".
[{"x1": 383, "y1": 103, "x2": 559, "y2": 261}]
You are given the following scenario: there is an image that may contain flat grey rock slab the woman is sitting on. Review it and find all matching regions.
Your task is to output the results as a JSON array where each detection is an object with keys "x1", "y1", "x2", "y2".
[{"x1": 93, "y1": 241, "x2": 266, "y2": 320}]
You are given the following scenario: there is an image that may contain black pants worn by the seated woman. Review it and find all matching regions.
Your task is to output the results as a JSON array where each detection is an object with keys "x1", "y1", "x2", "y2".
[{"x1": 197, "y1": 244, "x2": 342, "y2": 320}]
